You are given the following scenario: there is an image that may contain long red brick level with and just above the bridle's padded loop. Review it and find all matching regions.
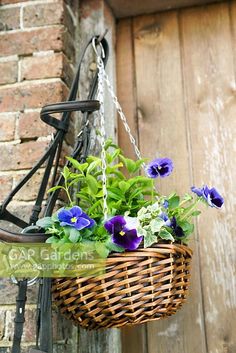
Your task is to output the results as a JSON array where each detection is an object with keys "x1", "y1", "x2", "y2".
[{"x1": 0, "y1": 82, "x2": 66, "y2": 112}]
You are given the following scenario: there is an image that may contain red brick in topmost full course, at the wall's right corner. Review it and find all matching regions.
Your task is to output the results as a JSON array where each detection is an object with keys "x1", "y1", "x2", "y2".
[{"x1": 23, "y1": 1, "x2": 63, "y2": 27}]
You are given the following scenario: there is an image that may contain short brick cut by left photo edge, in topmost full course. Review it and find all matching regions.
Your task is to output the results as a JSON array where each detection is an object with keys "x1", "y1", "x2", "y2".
[{"x1": 0, "y1": 7, "x2": 20, "y2": 31}]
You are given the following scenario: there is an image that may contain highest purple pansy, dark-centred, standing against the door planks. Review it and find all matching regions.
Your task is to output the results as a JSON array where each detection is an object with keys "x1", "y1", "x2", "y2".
[{"x1": 146, "y1": 158, "x2": 173, "y2": 178}]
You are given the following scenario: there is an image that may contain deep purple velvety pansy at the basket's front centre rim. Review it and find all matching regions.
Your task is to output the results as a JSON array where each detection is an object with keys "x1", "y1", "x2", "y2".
[{"x1": 104, "y1": 216, "x2": 143, "y2": 250}]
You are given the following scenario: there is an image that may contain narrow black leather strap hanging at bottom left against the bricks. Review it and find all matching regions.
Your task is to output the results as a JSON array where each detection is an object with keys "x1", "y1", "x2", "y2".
[{"x1": 12, "y1": 279, "x2": 27, "y2": 353}]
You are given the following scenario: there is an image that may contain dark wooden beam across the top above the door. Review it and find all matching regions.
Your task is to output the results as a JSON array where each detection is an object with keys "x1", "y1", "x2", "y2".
[{"x1": 106, "y1": 0, "x2": 220, "y2": 18}]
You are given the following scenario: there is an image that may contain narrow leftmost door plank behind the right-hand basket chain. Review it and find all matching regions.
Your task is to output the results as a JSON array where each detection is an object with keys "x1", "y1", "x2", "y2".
[{"x1": 116, "y1": 19, "x2": 146, "y2": 353}]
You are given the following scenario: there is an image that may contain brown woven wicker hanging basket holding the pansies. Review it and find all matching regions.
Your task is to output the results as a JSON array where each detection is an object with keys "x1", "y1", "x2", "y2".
[{"x1": 52, "y1": 243, "x2": 192, "y2": 329}]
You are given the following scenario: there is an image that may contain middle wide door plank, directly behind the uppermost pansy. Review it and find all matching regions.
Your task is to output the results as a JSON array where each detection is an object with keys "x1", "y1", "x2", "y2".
[{"x1": 134, "y1": 12, "x2": 206, "y2": 353}]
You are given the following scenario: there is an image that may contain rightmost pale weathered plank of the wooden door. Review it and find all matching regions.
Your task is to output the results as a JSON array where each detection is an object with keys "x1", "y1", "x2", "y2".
[{"x1": 180, "y1": 2, "x2": 236, "y2": 353}]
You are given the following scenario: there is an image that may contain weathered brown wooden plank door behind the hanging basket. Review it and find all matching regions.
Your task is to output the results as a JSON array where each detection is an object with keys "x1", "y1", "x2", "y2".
[{"x1": 117, "y1": 2, "x2": 236, "y2": 353}]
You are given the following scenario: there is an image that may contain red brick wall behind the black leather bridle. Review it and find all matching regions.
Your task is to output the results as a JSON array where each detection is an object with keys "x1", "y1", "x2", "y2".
[{"x1": 0, "y1": 0, "x2": 78, "y2": 353}]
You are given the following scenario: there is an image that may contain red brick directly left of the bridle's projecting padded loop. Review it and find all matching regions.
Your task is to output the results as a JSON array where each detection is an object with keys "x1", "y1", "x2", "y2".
[{"x1": 19, "y1": 112, "x2": 54, "y2": 139}]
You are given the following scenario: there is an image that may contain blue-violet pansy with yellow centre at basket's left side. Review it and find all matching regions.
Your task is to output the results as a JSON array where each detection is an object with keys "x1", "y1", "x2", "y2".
[{"x1": 57, "y1": 206, "x2": 95, "y2": 230}]
